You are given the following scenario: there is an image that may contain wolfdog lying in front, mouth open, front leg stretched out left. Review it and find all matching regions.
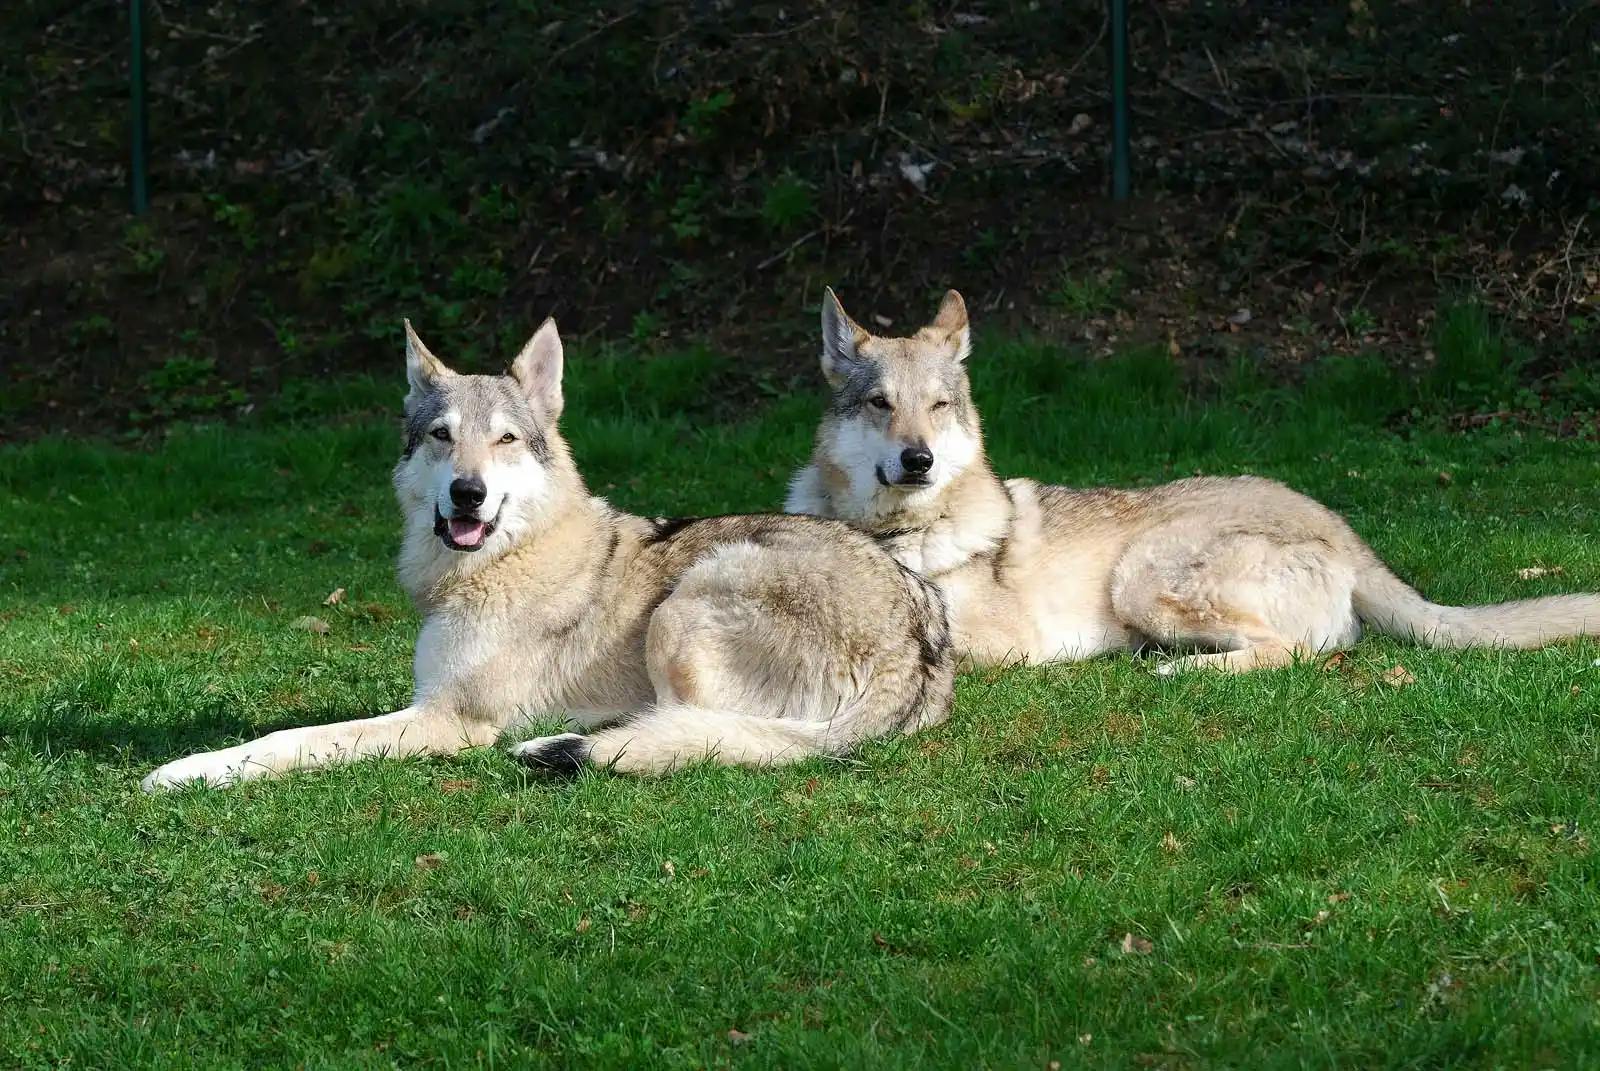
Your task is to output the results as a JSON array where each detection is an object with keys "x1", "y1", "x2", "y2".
[{"x1": 144, "y1": 320, "x2": 954, "y2": 789}]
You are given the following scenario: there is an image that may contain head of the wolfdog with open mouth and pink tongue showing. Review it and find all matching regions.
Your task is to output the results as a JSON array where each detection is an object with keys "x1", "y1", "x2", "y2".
[{"x1": 394, "y1": 320, "x2": 571, "y2": 554}]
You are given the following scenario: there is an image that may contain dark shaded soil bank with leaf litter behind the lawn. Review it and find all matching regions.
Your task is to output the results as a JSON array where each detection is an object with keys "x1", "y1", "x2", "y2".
[{"x1": 0, "y1": 0, "x2": 1600, "y2": 437}]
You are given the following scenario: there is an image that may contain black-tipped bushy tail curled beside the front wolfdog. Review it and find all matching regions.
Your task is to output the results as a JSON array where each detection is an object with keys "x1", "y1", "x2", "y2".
[{"x1": 512, "y1": 703, "x2": 859, "y2": 773}]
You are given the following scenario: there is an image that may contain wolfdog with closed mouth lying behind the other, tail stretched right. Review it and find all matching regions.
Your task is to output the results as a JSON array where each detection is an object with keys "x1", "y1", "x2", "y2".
[{"x1": 786, "y1": 290, "x2": 1600, "y2": 672}]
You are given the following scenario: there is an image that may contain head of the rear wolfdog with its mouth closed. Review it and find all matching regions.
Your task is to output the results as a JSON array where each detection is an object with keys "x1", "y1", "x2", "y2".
[{"x1": 818, "y1": 290, "x2": 982, "y2": 501}]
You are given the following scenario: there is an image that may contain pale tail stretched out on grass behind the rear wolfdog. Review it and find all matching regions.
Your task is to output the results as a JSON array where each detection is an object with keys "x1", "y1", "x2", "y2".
[{"x1": 1355, "y1": 557, "x2": 1600, "y2": 647}]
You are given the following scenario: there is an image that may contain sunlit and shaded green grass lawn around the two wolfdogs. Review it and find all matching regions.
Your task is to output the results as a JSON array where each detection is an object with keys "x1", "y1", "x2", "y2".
[{"x1": 0, "y1": 343, "x2": 1600, "y2": 1068}]
